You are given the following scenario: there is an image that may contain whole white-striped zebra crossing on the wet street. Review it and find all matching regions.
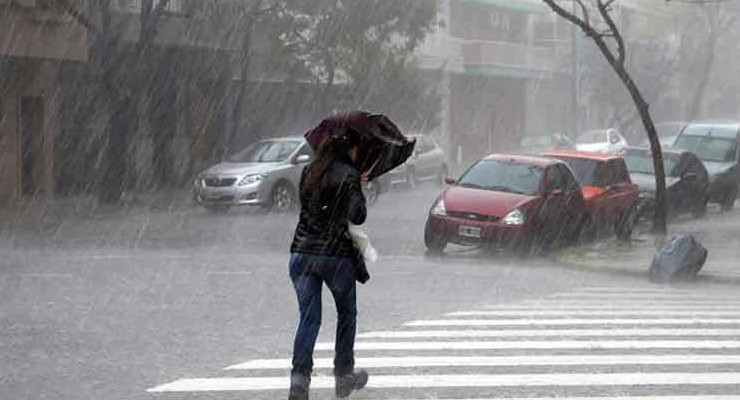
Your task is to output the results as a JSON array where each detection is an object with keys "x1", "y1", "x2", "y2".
[{"x1": 148, "y1": 287, "x2": 740, "y2": 400}]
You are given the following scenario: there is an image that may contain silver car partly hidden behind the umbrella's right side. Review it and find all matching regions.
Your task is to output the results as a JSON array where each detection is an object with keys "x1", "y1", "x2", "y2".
[{"x1": 386, "y1": 135, "x2": 449, "y2": 187}]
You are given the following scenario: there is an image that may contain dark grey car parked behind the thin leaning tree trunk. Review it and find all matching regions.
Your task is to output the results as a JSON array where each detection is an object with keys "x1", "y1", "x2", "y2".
[{"x1": 622, "y1": 147, "x2": 709, "y2": 218}]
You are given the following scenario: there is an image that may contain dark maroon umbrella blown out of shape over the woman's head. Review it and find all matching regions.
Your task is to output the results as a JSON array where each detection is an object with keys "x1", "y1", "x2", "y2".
[{"x1": 304, "y1": 111, "x2": 416, "y2": 180}]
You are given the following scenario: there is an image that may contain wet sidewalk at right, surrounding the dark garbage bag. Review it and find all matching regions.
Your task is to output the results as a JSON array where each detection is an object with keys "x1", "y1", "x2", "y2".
[{"x1": 558, "y1": 210, "x2": 740, "y2": 284}]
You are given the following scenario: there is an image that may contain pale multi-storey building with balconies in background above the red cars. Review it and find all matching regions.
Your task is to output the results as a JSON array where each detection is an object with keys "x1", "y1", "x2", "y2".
[{"x1": 418, "y1": 0, "x2": 575, "y2": 165}]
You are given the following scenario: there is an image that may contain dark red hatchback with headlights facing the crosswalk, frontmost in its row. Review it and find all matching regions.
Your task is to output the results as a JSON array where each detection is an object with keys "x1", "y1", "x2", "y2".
[{"x1": 424, "y1": 154, "x2": 587, "y2": 252}]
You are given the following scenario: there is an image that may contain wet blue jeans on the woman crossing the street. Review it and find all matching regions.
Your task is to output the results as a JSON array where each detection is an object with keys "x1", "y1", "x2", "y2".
[{"x1": 290, "y1": 253, "x2": 357, "y2": 375}]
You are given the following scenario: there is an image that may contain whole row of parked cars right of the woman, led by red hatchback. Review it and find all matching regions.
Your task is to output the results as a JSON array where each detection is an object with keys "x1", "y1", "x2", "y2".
[{"x1": 424, "y1": 123, "x2": 740, "y2": 252}]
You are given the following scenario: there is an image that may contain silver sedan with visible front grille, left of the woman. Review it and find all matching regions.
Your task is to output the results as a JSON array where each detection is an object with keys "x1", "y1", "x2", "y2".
[{"x1": 193, "y1": 137, "x2": 313, "y2": 212}]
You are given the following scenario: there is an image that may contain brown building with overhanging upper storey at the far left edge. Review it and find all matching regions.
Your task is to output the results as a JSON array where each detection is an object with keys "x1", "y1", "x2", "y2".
[{"x1": 0, "y1": 0, "x2": 88, "y2": 203}]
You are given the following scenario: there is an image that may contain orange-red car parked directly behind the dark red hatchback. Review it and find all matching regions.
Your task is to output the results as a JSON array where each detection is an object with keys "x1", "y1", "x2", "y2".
[{"x1": 544, "y1": 150, "x2": 640, "y2": 239}]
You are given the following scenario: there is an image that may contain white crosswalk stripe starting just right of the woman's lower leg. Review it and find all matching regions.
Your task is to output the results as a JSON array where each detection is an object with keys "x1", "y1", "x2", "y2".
[{"x1": 357, "y1": 329, "x2": 740, "y2": 339}]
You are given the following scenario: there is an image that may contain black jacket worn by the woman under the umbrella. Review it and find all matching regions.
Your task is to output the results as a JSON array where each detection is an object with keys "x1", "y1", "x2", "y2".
[{"x1": 290, "y1": 161, "x2": 367, "y2": 258}]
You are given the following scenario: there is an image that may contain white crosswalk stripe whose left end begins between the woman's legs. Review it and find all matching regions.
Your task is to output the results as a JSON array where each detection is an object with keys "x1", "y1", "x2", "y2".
[{"x1": 315, "y1": 340, "x2": 740, "y2": 351}]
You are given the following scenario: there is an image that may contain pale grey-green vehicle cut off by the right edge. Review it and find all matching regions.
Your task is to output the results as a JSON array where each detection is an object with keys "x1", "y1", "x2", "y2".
[{"x1": 673, "y1": 122, "x2": 740, "y2": 211}]
